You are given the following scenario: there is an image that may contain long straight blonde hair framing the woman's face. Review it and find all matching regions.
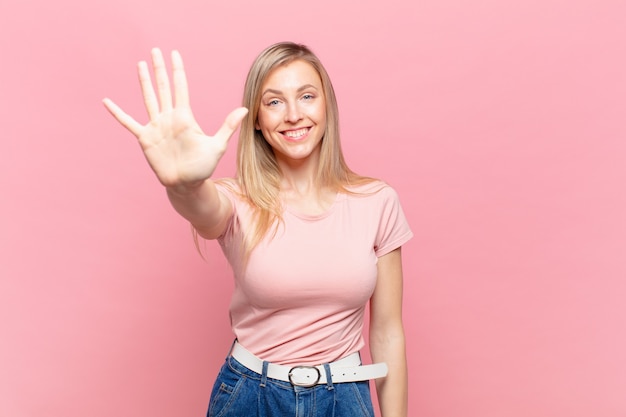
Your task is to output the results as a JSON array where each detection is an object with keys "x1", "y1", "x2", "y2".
[{"x1": 232, "y1": 42, "x2": 374, "y2": 258}]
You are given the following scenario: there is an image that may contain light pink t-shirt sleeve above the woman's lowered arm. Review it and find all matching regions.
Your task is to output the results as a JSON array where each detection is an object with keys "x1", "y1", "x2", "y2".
[{"x1": 374, "y1": 186, "x2": 413, "y2": 257}]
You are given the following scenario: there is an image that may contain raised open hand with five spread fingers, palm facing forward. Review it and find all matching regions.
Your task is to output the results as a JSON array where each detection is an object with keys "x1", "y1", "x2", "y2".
[{"x1": 103, "y1": 48, "x2": 248, "y2": 192}]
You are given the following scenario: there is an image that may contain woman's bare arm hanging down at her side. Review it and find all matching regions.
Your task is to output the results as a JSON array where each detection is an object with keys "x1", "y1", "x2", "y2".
[{"x1": 370, "y1": 248, "x2": 408, "y2": 417}]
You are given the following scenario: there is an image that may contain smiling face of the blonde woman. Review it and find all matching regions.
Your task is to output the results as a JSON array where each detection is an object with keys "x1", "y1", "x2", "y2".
[{"x1": 255, "y1": 60, "x2": 326, "y2": 162}]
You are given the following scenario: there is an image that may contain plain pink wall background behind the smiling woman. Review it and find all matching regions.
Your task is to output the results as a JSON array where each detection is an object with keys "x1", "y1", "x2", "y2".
[{"x1": 0, "y1": 0, "x2": 626, "y2": 417}]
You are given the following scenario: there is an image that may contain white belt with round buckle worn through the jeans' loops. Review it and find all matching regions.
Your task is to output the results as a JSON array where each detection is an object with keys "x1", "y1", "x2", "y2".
[{"x1": 230, "y1": 342, "x2": 387, "y2": 387}]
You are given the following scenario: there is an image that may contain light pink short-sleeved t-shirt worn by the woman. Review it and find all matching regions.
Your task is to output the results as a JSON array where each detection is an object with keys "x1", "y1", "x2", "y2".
[{"x1": 218, "y1": 183, "x2": 412, "y2": 365}]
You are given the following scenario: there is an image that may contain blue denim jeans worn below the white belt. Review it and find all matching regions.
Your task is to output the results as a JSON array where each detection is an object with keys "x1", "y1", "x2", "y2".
[{"x1": 207, "y1": 357, "x2": 374, "y2": 417}]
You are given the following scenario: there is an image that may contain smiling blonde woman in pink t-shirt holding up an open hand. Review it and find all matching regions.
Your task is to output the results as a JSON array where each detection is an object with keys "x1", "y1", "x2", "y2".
[{"x1": 104, "y1": 42, "x2": 412, "y2": 417}]
